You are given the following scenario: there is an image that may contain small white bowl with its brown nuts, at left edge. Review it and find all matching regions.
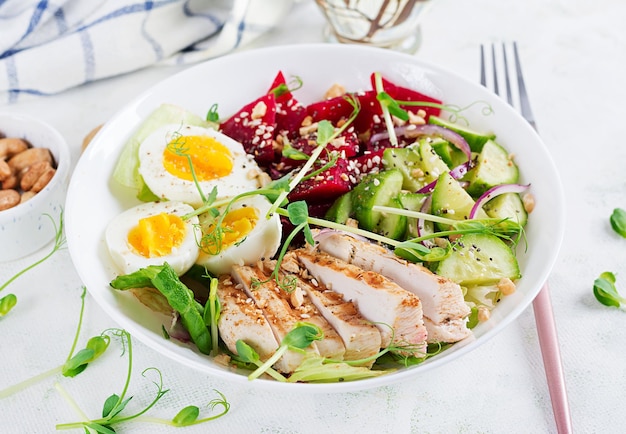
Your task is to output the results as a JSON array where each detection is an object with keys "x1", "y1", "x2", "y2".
[{"x1": 0, "y1": 112, "x2": 71, "y2": 261}]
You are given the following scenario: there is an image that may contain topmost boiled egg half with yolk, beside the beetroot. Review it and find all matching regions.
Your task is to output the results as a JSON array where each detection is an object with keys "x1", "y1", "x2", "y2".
[{"x1": 139, "y1": 124, "x2": 262, "y2": 207}]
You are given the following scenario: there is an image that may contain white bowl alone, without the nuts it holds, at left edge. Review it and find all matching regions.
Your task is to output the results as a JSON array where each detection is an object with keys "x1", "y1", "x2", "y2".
[{"x1": 0, "y1": 112, "x2": 71, "y2": 262}]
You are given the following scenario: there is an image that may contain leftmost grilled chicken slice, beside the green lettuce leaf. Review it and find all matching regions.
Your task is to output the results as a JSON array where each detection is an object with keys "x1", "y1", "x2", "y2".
[{"x1": 217, "y1": 276, "x2": 278, "y2": 361}]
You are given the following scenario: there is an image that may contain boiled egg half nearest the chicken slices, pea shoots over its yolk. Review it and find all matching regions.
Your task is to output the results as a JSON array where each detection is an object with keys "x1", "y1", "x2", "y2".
[{"x1": 196, "y1": 195, "x2": 282, "y2": 276}]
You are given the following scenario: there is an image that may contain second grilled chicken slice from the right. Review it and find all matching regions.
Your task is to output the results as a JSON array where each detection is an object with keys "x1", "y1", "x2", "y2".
[{"x1": 296, "y1": 250, "x2": 427, "y2": 355}]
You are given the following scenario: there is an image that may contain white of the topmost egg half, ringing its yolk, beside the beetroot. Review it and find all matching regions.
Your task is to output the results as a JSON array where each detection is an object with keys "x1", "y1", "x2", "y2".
[{"x1": 139, "y1": 124, "x2": 261, "y2": 207}]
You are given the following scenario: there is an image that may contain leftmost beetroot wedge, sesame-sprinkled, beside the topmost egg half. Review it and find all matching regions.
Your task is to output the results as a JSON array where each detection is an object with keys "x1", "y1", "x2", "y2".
[{"x1": 220, "y1": 93, "x2": 276, "y2": 166}]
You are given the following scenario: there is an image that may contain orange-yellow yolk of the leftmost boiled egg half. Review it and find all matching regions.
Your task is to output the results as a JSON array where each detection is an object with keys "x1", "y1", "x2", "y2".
[{"x1": 128, "y1": 213, "x2": 186, "y2": 258}]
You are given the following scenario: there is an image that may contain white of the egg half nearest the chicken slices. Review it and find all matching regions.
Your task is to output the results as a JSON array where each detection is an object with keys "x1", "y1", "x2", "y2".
[{"x1": 196, "y1": 195, "x2": 282, "y2": 276}]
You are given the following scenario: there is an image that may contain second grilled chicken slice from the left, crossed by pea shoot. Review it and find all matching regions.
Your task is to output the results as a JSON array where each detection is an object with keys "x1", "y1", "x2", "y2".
[{"x1": 232, "y1": 265, "x2": 319, "y2": 373}]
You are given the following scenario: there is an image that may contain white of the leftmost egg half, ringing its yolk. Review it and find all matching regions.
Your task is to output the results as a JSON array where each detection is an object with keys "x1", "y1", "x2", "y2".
[{"x1": 105, "y1": 202, "x2": 201, "y2": 276}]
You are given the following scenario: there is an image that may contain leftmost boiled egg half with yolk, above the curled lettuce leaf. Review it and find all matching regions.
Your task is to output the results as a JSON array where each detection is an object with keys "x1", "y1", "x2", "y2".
[{"x1": 105, "y1": 201, "x2": 201, "y2": 276}]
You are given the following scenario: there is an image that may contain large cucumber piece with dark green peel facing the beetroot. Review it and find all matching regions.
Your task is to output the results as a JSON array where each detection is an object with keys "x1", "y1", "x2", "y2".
[{"x1": 352, "y1": 169, "x2": 403, "y2": 231}]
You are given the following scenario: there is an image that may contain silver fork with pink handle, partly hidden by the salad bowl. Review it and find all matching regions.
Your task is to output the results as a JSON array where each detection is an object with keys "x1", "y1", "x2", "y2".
[{"x1": 480, "y1": 42, "x2": 572, "y2": 434}]
